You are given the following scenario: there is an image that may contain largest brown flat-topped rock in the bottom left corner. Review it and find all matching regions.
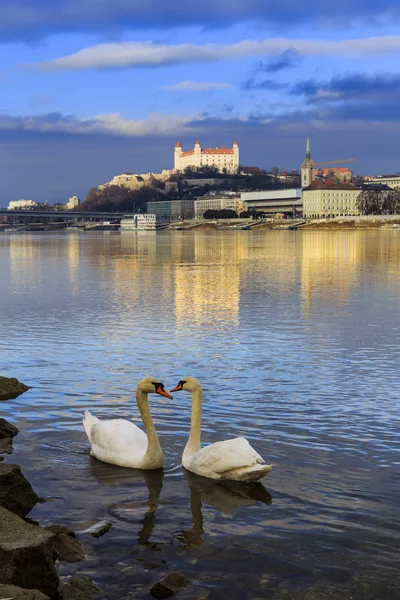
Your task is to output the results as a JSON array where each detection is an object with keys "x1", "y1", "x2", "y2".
[{"x1": 0, "y1": 506, "x2": 59, "y2": 597}]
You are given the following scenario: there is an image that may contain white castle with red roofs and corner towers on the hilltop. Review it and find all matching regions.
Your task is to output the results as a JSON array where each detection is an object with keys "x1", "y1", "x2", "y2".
[{"x1": 174, "y1": 140, "x2": 239, "y2": 173}]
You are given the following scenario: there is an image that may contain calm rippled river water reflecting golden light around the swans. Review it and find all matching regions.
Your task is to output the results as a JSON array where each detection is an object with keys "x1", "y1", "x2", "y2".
[{"x1": 0, "y1": 231, "x2": 400, "y2": 600}]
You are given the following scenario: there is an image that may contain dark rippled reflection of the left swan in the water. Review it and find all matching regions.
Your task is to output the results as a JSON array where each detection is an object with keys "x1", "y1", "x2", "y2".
[{"x1": 90, "y1": 459, "x2": 164, "y2": 549}]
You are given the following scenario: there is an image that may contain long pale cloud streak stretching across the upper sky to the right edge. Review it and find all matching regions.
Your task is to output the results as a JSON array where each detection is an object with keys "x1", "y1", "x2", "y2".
[{"x1": 29, "y1": 35, "x2": 400, "y2": 71}]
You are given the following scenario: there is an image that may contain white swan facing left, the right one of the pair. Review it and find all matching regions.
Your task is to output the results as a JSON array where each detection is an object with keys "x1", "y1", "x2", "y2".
[{"x1": 170, "y1": 377, "x2": 273, "y2": 481}]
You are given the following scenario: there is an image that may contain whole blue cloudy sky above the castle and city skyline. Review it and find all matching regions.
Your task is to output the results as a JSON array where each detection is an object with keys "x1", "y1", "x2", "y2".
[{"x1": 0, "y1": 0, "x2": 400, "y2": 207}]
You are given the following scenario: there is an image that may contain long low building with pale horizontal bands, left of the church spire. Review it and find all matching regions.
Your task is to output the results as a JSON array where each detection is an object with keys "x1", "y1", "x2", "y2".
[{"x1": 240, "y1": 188, "x2": 303, "y2": 216}]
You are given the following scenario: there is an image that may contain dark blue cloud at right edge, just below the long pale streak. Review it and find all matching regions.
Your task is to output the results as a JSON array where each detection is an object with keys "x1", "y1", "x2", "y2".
[{"x1": 290, "y1": 73, "x2": 400, "y2": 102}]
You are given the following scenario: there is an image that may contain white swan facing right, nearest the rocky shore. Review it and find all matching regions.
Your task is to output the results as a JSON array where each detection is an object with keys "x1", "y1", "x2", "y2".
[{"x1": 82, "y1": 377, "x2": 172, "y2": 469}]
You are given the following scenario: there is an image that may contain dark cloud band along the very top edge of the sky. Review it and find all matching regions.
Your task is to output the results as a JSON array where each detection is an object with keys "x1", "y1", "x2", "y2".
[{"x1": 0, "y1": 0, "x2": 400, "y2": 41}]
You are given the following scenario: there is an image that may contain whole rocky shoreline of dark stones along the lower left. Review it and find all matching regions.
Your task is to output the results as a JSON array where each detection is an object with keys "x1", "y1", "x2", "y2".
[{"x1": 0, "y1": 377, "x2": 209, "y2": 600}]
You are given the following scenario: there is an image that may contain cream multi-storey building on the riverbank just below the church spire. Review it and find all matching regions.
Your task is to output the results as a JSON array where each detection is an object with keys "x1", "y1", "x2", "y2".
[{"x1": 303, "y1": 180, "x2": 361, "y2": 219}]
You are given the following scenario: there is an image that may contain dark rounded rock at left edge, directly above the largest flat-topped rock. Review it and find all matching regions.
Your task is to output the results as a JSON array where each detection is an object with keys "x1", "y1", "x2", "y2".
[{"x1": 0, "y1": 464, "x2": 39, "y2": 517}]
